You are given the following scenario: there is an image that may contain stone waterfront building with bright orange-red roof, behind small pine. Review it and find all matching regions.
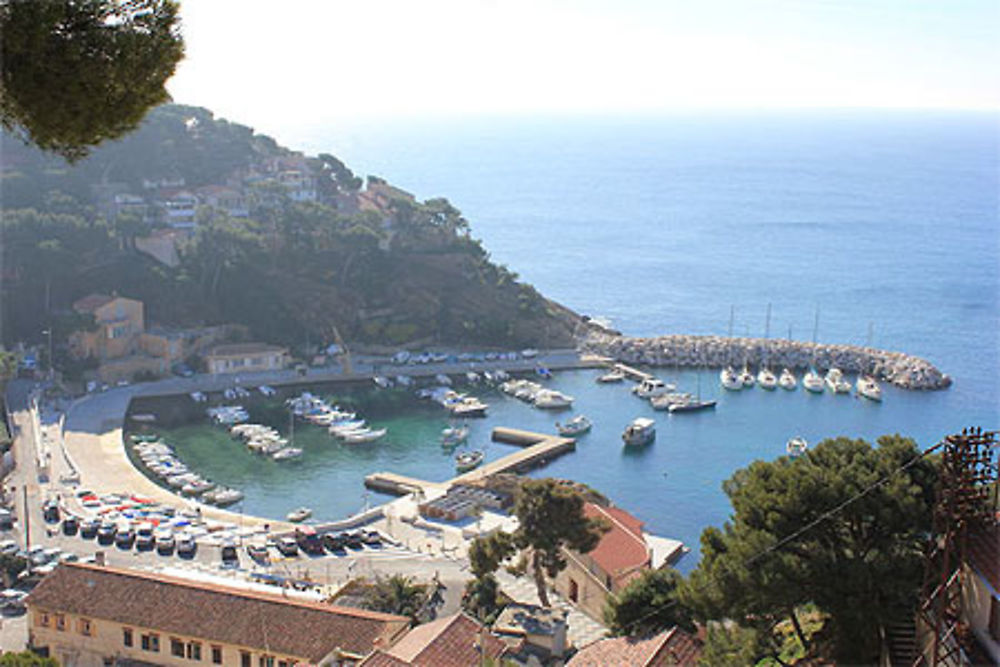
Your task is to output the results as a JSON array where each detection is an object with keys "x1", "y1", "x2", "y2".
[{"x1": 554, "y1": 503, "x2": 653, "y2": 619}]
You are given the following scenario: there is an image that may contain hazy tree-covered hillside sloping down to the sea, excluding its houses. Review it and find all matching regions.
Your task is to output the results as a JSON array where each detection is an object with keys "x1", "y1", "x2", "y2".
[{"x1": 0, "y1": 105, "x2": 580, "y2": 346}]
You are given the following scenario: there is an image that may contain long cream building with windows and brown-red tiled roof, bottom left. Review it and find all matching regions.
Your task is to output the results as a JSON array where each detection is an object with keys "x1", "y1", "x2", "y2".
[{"x1": 25, "y1": 563, "x2": 409, "y2": 667}]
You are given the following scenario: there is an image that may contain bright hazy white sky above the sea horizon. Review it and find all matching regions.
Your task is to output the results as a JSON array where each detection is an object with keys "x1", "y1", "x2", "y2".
[{"x1": 169, "y1": 0, "x2": 1000, "y2": 132}]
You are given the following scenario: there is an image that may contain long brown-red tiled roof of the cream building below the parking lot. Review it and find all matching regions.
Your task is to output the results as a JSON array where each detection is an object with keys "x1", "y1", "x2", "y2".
[{"x1": 27, "y1": 563, "x2": 409, "y2": 662}]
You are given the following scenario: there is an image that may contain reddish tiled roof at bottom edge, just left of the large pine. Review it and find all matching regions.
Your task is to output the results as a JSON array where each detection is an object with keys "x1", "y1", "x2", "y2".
[{"x1": 566, "y1": 628, "x2": 701, "y2": 667}]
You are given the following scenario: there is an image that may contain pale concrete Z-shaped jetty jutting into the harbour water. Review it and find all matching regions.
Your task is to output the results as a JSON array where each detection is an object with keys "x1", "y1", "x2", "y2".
[{"x1": 365, "y1": 427, "x2": 576, "y2": 495}]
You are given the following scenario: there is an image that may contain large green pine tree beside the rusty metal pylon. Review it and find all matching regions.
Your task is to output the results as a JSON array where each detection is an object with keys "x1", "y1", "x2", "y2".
[{"x1": 681, "y1": 435, "x2": 936, "y2": 662}]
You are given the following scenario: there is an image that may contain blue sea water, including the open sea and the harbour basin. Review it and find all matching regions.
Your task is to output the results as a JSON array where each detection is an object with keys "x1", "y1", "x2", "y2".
[{"x1": 158, "y1": 112, "x2": 1000, "y2": 568}]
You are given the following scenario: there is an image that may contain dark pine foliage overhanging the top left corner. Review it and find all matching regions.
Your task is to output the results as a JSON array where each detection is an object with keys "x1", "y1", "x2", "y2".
[{"x1": 0, "y1": 0, "x2": 184, "y2": 161}]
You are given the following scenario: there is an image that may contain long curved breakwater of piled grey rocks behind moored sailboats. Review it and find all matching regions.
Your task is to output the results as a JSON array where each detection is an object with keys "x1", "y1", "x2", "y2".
[{"x1": 583, "y1": 333, "x2": 951, "y2": 389}]
